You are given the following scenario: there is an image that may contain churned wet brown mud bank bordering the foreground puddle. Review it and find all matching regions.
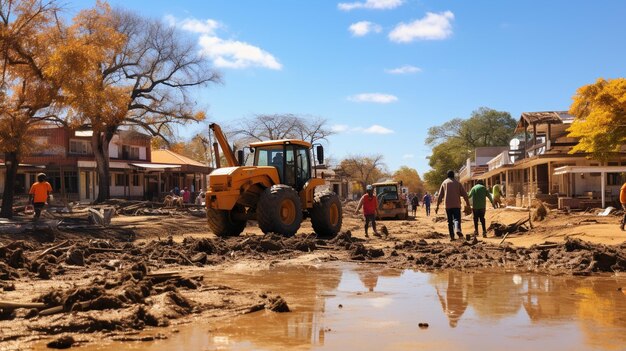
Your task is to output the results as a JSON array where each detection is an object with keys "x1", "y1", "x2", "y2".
[{"x1": 0, "y1": 224, "x2": 626, "y2": 349}]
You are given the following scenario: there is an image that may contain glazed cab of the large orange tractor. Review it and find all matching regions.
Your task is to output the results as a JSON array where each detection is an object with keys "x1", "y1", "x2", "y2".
[{"x1": 250, "y1": 140, "x2": 311, "y2": 191}]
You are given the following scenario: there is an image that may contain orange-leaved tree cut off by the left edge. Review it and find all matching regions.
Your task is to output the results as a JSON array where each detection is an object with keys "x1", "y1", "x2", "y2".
[{"x1": 0, "y1": 0, "x2": 61, "y2": 218}]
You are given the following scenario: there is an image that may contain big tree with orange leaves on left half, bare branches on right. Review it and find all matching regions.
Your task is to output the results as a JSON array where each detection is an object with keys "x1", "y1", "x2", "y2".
[{"x1": 48, "y1": 1, "x2": 220, "y2": 202}]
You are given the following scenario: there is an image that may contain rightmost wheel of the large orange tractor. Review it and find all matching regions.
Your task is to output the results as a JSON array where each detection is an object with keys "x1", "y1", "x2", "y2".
[{"x1": 310, "y1": 192, "x2": 342, "y2": 237}]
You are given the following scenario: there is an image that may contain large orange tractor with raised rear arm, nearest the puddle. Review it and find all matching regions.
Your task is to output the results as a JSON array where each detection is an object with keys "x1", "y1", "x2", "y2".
[{"x1": 206, "y1": 123, "x2": 342, "y2": 237}]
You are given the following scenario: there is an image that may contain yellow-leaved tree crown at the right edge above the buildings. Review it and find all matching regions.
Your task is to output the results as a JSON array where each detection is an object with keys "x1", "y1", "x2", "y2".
[{"x1": 568, "y1": 78, "x2": 626, "y2": 160}]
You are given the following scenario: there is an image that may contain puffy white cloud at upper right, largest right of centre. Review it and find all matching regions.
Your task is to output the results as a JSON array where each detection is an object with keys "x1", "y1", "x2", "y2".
[{"x1": 389, "y1": 11, "x2": 454, "y2": 43}]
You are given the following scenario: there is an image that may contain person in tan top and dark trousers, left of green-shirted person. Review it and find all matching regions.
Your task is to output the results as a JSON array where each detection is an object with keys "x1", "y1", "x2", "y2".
[{"x1": 435, "y1": 171, "x2": 472, "y2": 241}]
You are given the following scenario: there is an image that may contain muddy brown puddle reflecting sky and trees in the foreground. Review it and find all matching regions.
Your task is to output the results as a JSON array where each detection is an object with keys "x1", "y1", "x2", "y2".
[{"x1": 34, "y1": 263, "x2": 626, "y2": 351}]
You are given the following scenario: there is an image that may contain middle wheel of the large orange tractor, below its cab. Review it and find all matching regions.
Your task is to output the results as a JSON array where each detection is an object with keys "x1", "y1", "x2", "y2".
[{"x1": 256, "y1": 185, "x2": 302, "y2": 236}]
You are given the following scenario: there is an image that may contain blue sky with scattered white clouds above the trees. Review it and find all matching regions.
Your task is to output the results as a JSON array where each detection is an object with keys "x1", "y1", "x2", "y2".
[{"x1": 68, "y1": 0, "x2": 626, "y2": 174}]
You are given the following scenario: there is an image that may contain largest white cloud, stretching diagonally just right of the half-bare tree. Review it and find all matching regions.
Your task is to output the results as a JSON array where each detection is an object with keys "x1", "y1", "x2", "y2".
[{"x1": 164, "y1": 15, "x2": 282, "y2": 70}]
